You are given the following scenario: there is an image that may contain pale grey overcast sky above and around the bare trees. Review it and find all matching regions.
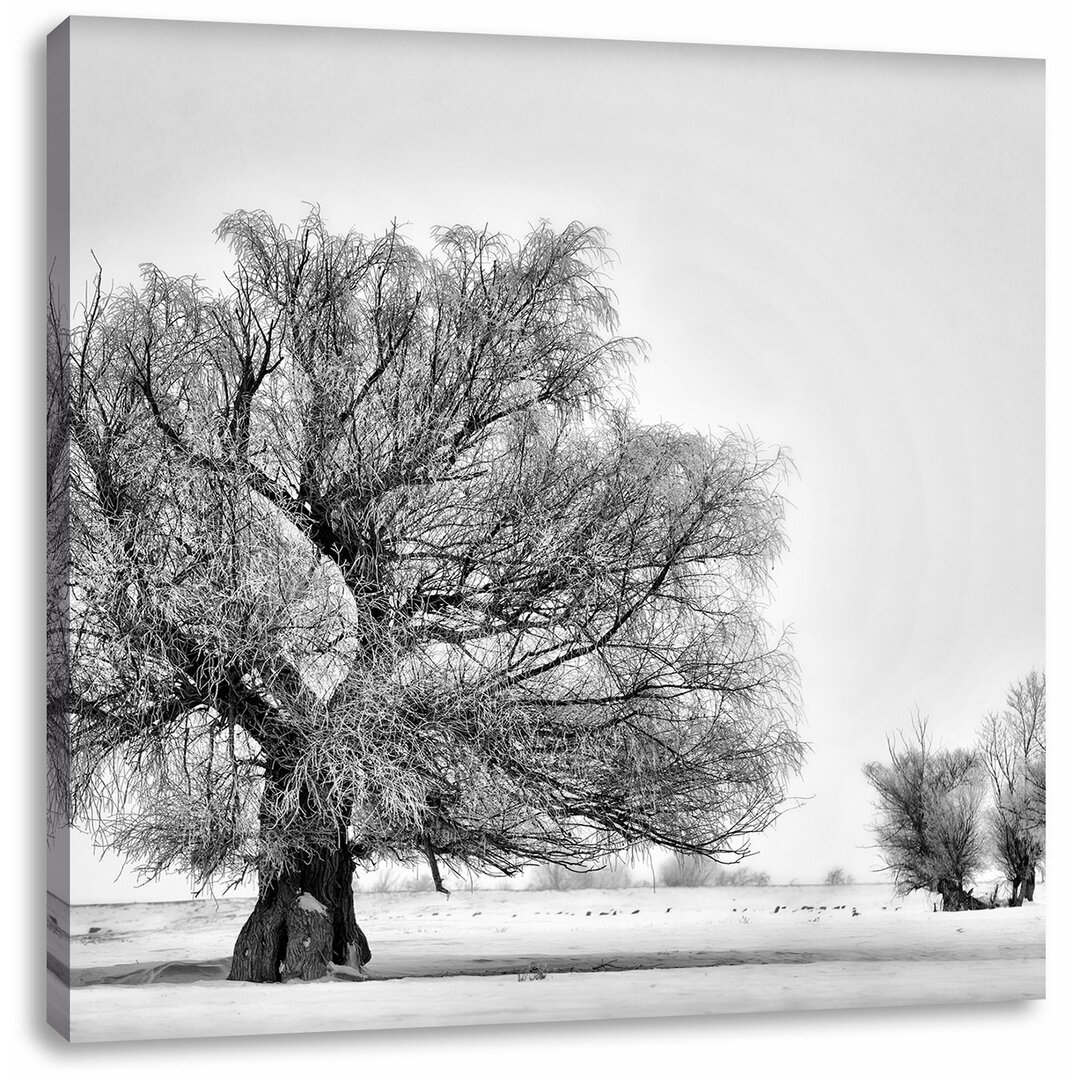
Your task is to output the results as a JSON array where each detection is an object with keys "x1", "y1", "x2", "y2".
[{"x1": 63, "y1": 19, "x2": 1045, "y2": 902}]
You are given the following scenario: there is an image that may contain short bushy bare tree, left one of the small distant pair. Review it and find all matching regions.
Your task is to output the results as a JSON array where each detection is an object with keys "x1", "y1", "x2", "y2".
[{"x1": 863, "y1": 717, "x2": 985, "y2": 912}]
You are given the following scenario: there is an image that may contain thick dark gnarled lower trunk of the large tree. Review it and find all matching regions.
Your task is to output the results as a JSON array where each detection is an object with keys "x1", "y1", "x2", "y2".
[{"x1": 229, "y1": 827, "x2": 372, "y2": 983}]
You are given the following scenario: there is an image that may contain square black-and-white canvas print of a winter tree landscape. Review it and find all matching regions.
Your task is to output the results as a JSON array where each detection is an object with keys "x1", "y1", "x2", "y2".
[{"x1": 46, "y1": 17, "x2": 1048, "y2": 1041}]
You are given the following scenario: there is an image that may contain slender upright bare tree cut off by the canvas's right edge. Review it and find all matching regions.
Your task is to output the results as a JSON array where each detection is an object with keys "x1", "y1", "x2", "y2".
[{"x1": 980, "y1": 671, "x2": 1047, "y2": 906}]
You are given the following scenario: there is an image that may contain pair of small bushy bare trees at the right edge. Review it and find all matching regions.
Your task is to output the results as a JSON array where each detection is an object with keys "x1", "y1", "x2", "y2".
[{"x1": 868, "y1": 672, "x2": 1047, "y2": 912}]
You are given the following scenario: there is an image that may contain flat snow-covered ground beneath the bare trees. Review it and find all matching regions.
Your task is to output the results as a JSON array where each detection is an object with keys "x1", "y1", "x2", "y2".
[{"x1": 49, "y1": 885, "x2": 1045, "y2": 1041}]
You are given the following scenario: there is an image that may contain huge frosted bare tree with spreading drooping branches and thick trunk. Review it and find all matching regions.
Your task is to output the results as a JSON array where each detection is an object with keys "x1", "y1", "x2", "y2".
[{"x1": 52, "y1": 212, "x2": 802, "y2": 981}]
